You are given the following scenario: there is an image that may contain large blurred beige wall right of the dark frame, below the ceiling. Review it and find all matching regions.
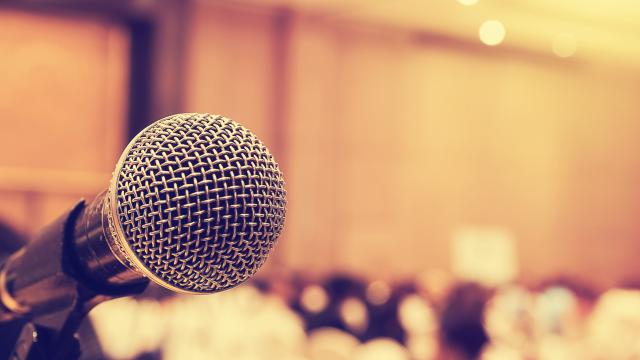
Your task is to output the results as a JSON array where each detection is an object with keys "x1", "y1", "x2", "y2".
[{"x1": 182, "y1": 2, "x2": 640, "y2": 285}]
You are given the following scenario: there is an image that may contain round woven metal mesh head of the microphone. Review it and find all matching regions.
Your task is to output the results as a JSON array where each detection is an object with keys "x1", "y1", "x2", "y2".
[{"x1": 106, "y1": 114, "x2": 286, "y2": 293}]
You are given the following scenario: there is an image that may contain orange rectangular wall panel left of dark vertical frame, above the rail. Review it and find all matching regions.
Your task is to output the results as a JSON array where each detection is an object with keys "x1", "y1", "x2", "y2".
[{"x1": 0, "y1": 10, "x2": 128, "y2": 171}]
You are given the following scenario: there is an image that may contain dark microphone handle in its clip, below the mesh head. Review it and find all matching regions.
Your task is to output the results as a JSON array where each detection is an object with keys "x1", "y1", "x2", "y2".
[{"x1": 0, "y1": 198, "x2": 149, "y2": 328}]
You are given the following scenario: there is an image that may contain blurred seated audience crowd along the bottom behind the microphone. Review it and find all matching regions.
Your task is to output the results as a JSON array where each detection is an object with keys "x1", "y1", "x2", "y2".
[{"x1": 86, "y1": 275, "x2": 640, "y2": 360}]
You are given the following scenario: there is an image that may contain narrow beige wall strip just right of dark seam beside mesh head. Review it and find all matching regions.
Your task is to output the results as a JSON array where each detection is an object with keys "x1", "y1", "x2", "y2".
[{"x1": 284, "y1": 19, "x2": 351, "y2": 273}]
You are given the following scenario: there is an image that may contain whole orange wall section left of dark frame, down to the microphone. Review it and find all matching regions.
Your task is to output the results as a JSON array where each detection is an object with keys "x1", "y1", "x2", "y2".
[{"x1": 0, "y1": 9, "x2": 129, "y2": 234}]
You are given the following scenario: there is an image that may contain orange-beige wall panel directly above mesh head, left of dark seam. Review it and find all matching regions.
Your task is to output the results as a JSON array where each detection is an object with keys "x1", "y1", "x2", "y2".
[{"x1": 185, "y1": 2, "x2": 275, "y2": 146}]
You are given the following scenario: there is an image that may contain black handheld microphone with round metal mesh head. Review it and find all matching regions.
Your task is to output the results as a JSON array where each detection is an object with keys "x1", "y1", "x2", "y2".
[{"x1": 0, "y1": 113, "x2": 286, "y2": 321}]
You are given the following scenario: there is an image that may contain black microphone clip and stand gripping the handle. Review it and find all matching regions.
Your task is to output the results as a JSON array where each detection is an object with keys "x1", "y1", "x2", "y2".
[{"x1": 0, "y1": 200, "x2": 149, "y2": 360}]
